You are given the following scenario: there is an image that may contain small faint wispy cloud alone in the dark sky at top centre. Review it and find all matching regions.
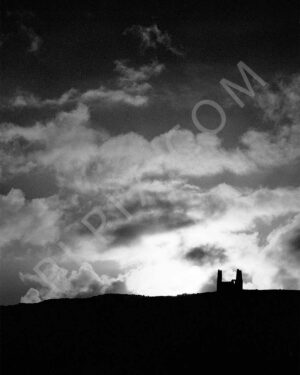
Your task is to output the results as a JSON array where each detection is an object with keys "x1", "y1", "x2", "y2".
[{"x1": 124, "y1": 24, "x2": 184, "y2": 57}]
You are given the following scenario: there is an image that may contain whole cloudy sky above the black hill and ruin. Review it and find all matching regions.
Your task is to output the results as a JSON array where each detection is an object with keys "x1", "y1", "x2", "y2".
[{"x1": 0, "y1": 0, "x2": 300, "y2": 304}]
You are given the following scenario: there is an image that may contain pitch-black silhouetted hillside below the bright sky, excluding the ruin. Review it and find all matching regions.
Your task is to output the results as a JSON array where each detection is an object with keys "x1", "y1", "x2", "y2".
[{"x1": 0, "y1": 291, "x2": 300, "y2": 375}]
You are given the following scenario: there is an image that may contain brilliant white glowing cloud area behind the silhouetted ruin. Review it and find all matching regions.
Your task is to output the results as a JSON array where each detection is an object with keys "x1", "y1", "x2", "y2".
[{"x1": 65, "y1": 185, "x2": 299, "y2": 295}]
